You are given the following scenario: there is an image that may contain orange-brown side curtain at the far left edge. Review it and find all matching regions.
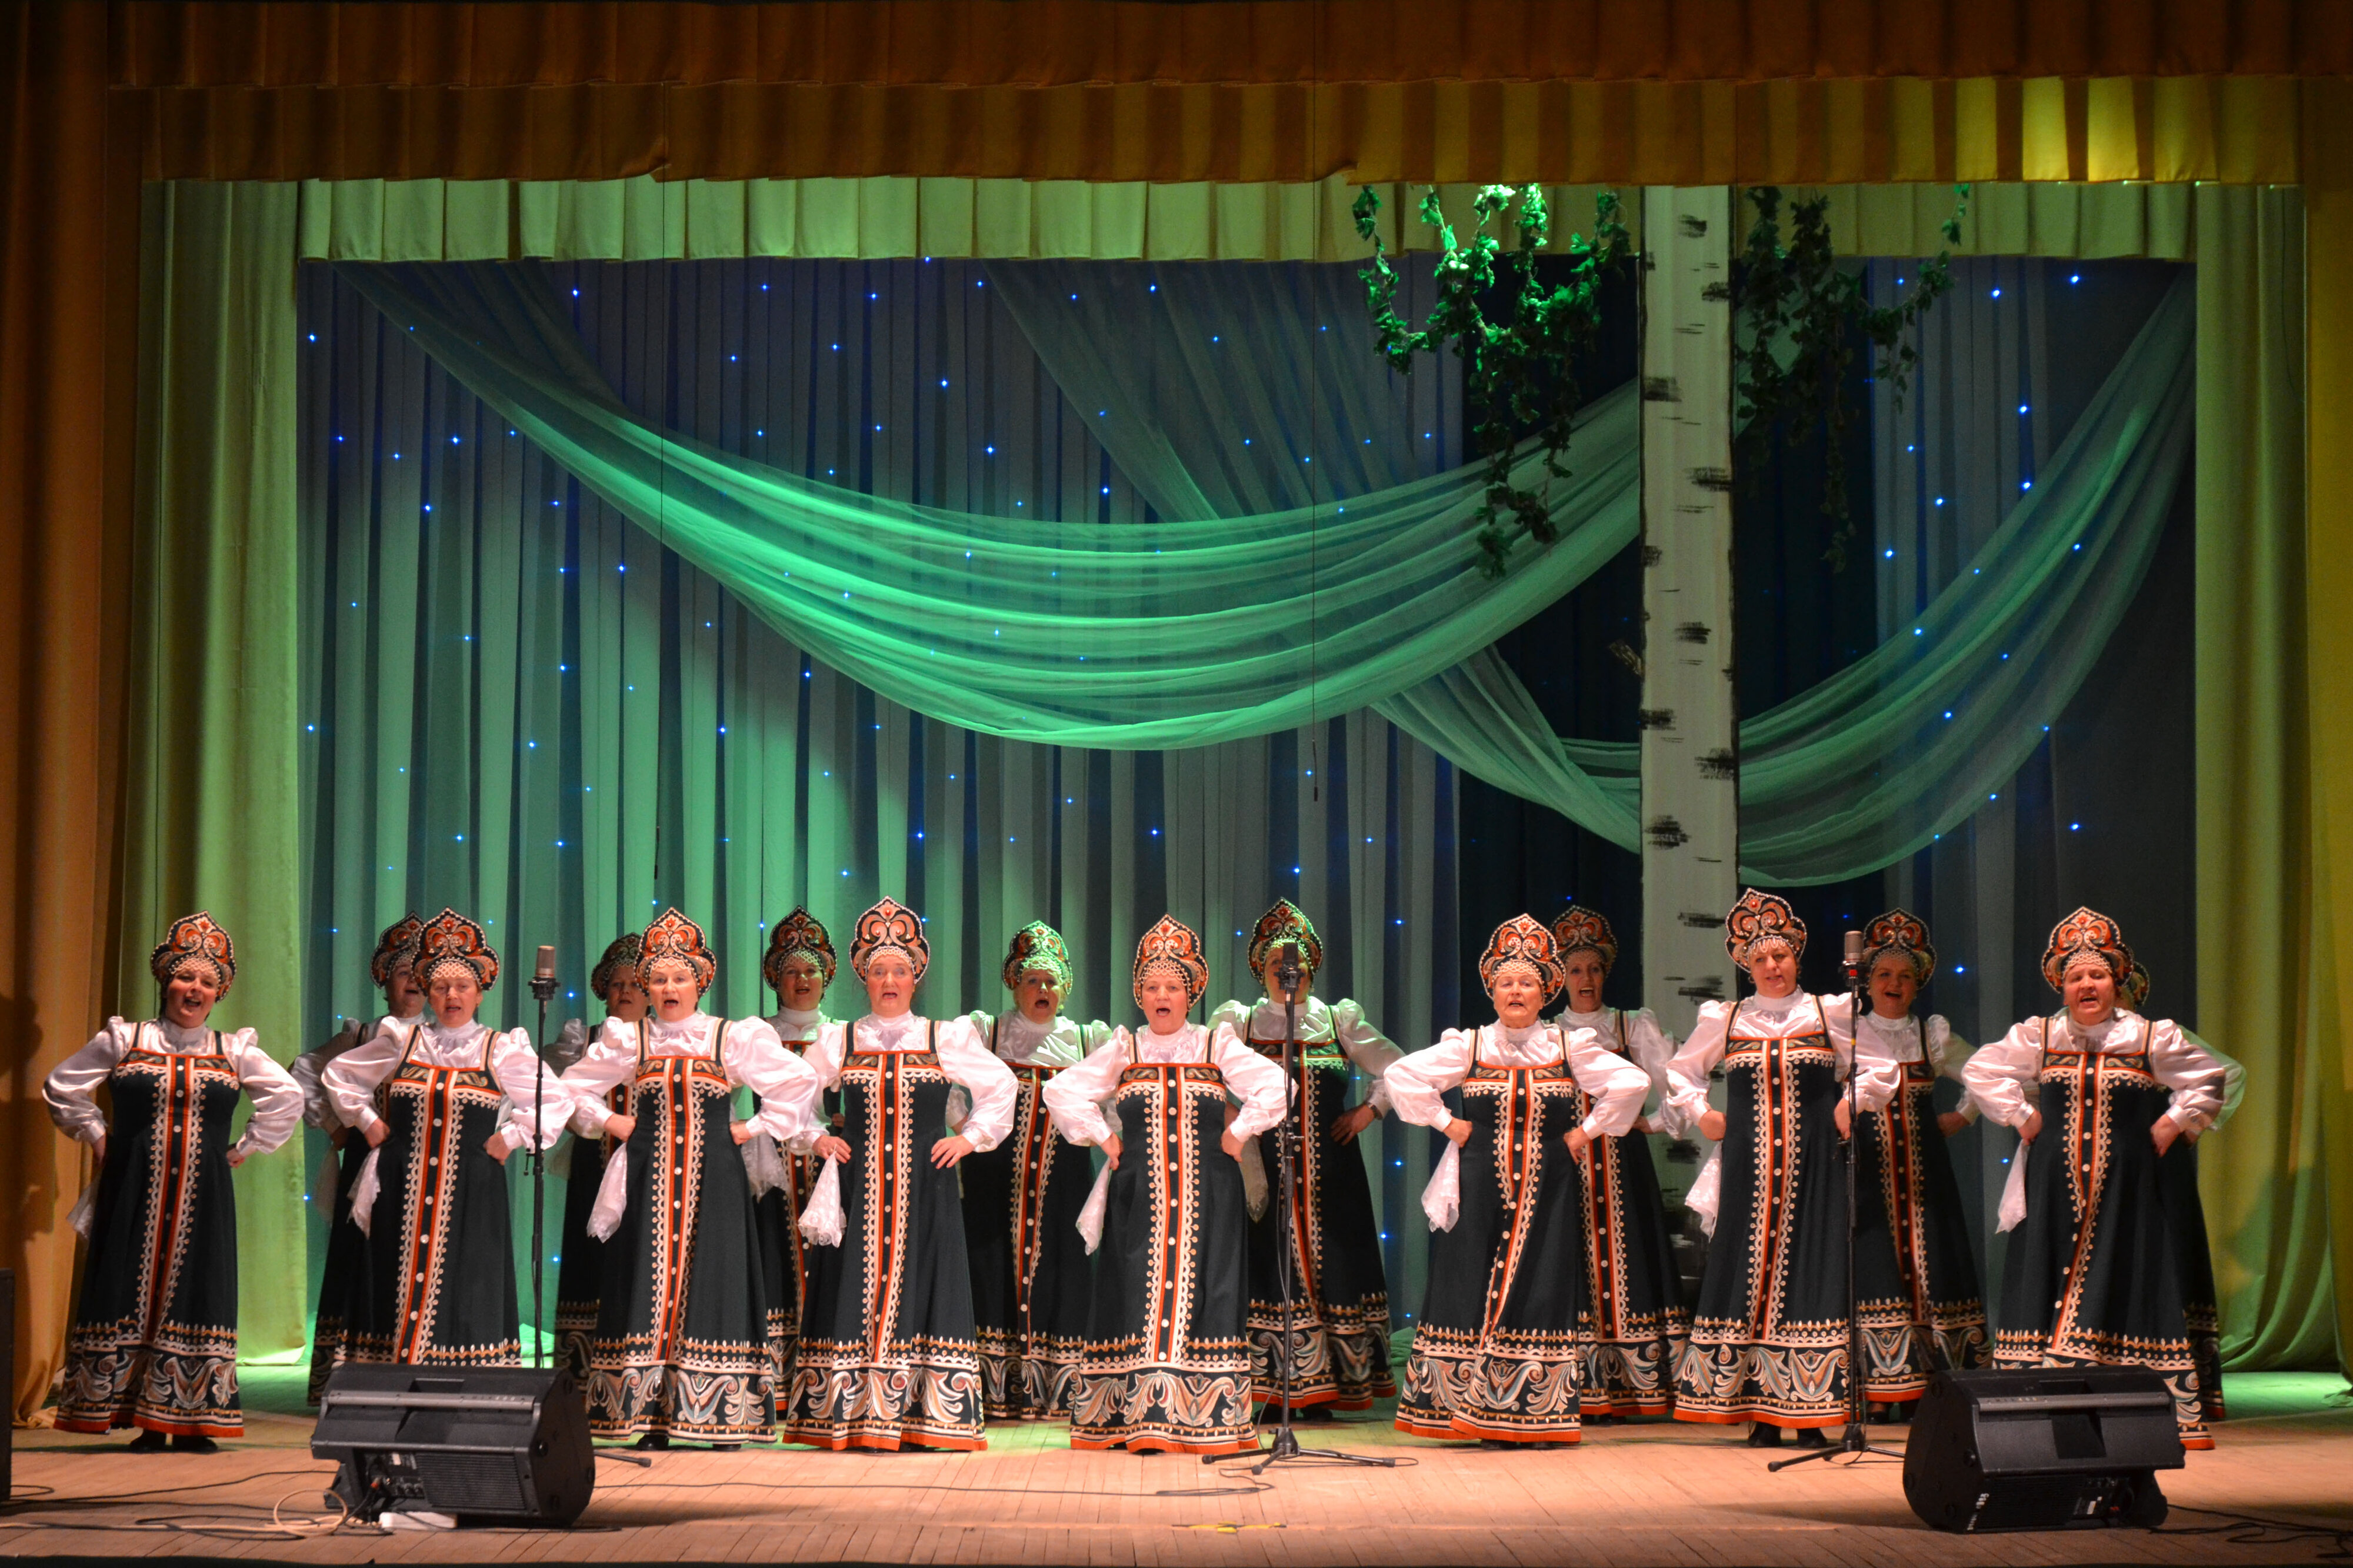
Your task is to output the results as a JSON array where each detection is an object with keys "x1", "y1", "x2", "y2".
[{"x1": 0, "y1": 5, "x2": 146, "y2": 1420}]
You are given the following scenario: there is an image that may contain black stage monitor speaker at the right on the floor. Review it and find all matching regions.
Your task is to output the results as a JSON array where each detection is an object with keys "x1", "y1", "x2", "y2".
[{"x1": 1904, "y1": 1366, "x2": 2181, "y2": 1533}]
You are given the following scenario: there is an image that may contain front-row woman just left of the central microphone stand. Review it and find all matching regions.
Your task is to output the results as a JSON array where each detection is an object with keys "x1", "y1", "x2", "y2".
[{"x1": 1045, "y1": 916, "x2": 1285, "y2": 1455}]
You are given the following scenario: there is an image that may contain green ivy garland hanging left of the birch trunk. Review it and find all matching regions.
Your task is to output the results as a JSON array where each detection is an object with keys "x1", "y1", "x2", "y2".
[{"x1": 1353, "y1": 186, "x2": 1633, "y2": 577}]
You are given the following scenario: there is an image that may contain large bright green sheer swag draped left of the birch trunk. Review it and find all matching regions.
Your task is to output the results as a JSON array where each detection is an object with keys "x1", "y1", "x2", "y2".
[{"x1": 348, "y1": 266, "x2": 1638, "y2": 746}]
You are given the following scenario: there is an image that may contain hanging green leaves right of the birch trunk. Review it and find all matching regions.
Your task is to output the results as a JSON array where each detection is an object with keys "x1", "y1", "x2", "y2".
[{"x1": 1732, "y1": 186, "x2": 1969, "y2": 572}]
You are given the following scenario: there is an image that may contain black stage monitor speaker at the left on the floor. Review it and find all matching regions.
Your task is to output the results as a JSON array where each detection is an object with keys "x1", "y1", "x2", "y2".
[{"x1": 311, "y1": 1366, "x2": 595, "y2": 1526}]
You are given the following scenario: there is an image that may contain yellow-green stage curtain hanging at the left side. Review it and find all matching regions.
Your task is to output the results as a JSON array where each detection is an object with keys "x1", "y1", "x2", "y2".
[{"x1": 118, "y1": 184, "x2": 308, "y2": 1361}]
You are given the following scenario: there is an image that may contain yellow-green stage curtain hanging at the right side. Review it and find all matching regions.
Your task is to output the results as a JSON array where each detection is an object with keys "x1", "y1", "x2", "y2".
[{"x1": 2195, "y1": 186, "x2": 2341, "y2": 1368}]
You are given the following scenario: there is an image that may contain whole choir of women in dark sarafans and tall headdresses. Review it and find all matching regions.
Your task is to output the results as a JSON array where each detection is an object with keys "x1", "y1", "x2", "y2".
[{"x1": 42, "y1": 890, "x2": 2242, "y2": 1455}]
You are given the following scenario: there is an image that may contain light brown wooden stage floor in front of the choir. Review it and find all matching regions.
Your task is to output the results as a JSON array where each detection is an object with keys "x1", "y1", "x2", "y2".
[{"x1": 0, "y1": 1370, "x2": 2353, "y2": 1568}]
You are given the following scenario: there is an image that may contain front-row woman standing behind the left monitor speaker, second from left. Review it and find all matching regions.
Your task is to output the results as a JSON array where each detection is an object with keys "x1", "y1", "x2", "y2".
[{"x1": 320, "y1": 909, "x2": 572, "y2": 1366}]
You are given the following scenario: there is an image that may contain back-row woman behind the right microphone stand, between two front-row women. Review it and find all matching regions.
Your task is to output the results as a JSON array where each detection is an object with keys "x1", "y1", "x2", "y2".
[{"x1": 1833, "y1": 909, "x2": 1993, "y2": 1420}]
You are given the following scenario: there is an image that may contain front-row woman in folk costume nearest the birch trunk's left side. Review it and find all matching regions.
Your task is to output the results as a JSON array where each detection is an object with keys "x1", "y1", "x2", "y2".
[{"x1": 1388, "y1": 913, "x2": 1649, "y2": 1446}]
